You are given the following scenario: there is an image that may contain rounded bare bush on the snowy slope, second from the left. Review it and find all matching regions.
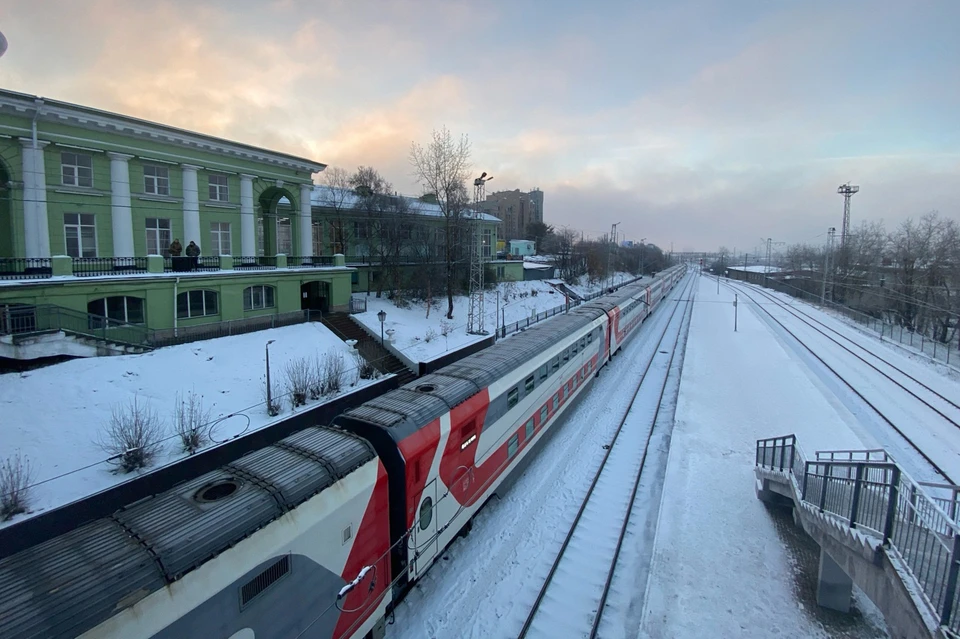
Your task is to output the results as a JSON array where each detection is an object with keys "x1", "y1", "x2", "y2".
[{"x1": 97, "y1": 395, "x2": 163, "y2": 473}]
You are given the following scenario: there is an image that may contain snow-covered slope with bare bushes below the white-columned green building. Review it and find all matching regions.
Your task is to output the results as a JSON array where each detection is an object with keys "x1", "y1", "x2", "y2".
[{"x1": 0, "y1": 323, "x2": 376, "y2": 524}]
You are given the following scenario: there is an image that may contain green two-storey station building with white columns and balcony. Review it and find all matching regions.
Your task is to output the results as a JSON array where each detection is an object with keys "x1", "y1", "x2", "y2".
[{"x1": 0, "y1": 90, "x2": 503, "y2": 358}]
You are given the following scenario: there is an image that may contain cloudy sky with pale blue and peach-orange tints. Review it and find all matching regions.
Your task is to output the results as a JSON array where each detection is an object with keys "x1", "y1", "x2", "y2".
[{"x1": 0, "y1": 0, "x2": 960, "y2": 252}]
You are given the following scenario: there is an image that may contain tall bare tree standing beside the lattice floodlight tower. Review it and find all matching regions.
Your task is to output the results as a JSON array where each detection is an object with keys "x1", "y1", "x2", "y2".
[{"x1": 410, "y1": 127, "x2": 470, "y2": 319}]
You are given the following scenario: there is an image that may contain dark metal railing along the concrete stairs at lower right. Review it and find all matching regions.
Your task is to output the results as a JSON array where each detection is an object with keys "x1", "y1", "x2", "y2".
[{"x1": 756, "y1": 435, "x2": 960, "y2": 632}]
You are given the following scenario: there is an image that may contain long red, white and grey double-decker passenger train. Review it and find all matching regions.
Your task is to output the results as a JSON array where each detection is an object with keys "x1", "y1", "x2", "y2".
[{"x1": 0, "y1": 266, "x2": 685, "y2": 639}]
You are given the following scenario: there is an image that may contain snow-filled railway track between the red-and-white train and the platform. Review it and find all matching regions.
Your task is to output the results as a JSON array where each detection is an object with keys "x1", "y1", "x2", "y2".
[{"x1": 519, "y1": 278, "x2": 697, "y2": 638}]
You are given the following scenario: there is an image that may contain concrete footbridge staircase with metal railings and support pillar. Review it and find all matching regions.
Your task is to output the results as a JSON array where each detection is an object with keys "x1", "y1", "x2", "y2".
[{"x1": 755, "y1": 435, "x2": 960, "y2": 639}]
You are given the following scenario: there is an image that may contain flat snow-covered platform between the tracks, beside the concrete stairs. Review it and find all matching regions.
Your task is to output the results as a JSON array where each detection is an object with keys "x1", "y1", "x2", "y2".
[{"x1": 638, "y1": 278, "x2": 875, "y2": 639}]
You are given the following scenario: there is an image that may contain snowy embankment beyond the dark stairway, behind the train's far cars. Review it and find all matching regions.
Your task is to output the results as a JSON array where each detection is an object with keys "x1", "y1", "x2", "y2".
[{"x1": 353, "y1": 273, "x2": 636, "y2": 362}]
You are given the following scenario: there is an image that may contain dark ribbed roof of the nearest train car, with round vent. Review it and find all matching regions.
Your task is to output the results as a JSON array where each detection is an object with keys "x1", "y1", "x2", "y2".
[{"x1": 0, "y1": 427, "x2": 374, "y2": 639}]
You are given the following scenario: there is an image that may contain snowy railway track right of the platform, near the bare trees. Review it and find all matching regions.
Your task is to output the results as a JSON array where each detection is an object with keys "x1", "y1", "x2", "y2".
[{"x1": 724, "y1": 283, "x2": 960, "y2": 484}]
